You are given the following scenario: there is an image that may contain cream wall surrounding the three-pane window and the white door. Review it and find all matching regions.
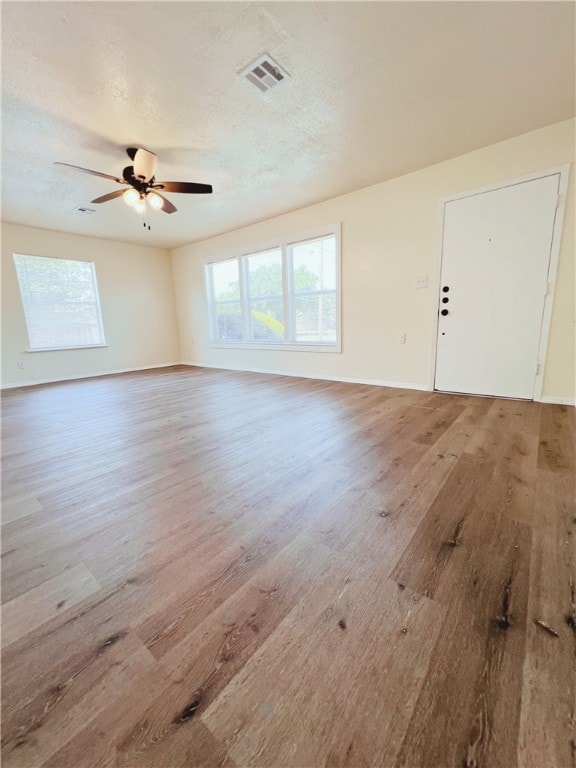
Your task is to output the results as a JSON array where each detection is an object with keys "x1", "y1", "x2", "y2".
[{"x1": 172, "y1": 120, "x2": 575, "y2": 399}]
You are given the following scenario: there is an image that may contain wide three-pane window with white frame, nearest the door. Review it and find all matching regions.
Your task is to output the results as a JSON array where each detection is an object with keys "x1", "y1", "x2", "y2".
[{"x1": 206, "y1": 226, "x2": 340, "y2": 352}]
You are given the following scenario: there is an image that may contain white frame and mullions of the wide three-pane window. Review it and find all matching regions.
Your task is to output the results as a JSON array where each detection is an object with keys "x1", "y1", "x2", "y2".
[{"x1": 204, "y1": 222, "x2": 342, "y2": 354}]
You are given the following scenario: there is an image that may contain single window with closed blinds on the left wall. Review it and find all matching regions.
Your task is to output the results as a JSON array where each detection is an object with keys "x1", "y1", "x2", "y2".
[{"x1": 14, "y1": 253, "x2": 105, "y2": 350}]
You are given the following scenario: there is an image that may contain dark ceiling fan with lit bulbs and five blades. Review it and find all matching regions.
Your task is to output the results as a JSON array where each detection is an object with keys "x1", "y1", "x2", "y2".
[{"x1": 54, "y1": 147, "x2": 212, "y2": 213}]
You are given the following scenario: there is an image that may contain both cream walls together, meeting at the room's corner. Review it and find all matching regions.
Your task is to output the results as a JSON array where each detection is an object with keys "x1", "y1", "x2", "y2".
[{"x1": 2, "y1": 120, "x2": 576, "y2": 400}]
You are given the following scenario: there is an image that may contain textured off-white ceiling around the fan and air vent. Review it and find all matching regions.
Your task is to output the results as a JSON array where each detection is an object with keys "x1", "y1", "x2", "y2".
[{"x1": 2, "y1": 1, "x2": 575, "y2": 248}]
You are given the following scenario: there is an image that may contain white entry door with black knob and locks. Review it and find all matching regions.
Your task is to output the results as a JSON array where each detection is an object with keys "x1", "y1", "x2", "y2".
[{"x1": 435, "y1": 173, "x2": 560, "y2": 399}]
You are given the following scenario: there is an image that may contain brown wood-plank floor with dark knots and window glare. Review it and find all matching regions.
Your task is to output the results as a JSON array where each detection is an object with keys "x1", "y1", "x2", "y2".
[{"x1": 2, "y1": 367, "x2": 576, "y2": 768}]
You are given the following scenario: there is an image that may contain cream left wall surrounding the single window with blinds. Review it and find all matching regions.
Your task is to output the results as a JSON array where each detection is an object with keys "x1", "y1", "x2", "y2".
[{"x1": 2, "y1": 224, "x2": 180, "y2": 387}]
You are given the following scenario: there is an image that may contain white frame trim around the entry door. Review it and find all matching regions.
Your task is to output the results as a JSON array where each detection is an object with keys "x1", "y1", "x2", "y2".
[{"x1": 428, "y1": 163, "x2": 570, "y2": 402}]
